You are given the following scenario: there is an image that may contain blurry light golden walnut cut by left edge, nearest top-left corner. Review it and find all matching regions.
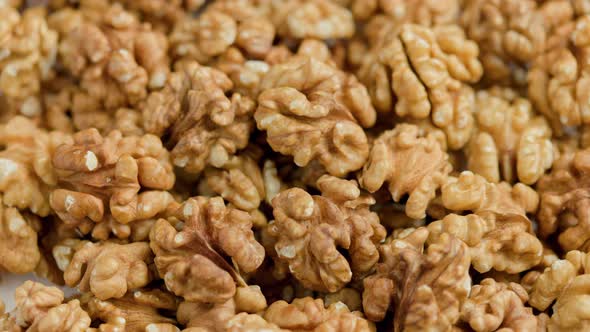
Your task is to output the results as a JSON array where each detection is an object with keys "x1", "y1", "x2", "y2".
[{"x1": 0, "y1": 2, "x2": 58, "y2": 122}]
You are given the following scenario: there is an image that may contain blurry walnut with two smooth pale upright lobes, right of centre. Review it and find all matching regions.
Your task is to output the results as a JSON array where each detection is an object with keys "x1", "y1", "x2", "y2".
[{"x1": 466, "y1": 87, "x2": 553, "y2": 185}]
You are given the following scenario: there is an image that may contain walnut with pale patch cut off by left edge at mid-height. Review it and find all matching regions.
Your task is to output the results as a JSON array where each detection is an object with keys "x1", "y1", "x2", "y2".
[{"x1": 0, "y1": 116, "x2": 71, "y2": 217}]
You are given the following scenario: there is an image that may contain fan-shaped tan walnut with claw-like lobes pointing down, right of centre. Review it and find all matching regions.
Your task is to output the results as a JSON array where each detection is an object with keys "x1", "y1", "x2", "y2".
[{"x1": 359, "y1": 124, "x2": 452, "y2": 219}]
